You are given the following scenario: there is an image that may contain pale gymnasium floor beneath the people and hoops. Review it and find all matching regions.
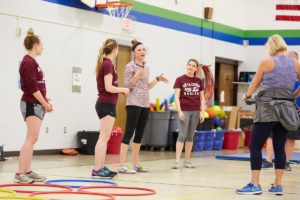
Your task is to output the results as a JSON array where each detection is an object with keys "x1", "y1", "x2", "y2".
[{"x1": 0, "y1": 149, "x2": 300, "y2": 200}]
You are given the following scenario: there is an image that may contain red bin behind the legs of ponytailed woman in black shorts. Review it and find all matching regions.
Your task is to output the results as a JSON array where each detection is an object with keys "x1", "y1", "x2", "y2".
[{"x1": 106, "y1": 127, "x2": 123, "y2": 154}]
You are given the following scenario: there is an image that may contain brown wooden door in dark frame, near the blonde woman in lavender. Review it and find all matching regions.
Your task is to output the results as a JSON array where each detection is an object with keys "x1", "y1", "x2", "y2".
[{"x1": 215, "y1": 58, "x2": 238, "y2": 106}]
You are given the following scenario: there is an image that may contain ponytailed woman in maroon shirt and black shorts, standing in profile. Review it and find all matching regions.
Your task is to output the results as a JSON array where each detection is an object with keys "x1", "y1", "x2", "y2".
[{"x1": 92, "y1": 39, "x2": 129, "y2": 179}]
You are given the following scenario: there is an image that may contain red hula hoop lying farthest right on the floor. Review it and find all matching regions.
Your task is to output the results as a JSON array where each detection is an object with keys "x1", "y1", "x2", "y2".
[{"x1": 78, "y1": 186, "x2": 156, "y2": 196}]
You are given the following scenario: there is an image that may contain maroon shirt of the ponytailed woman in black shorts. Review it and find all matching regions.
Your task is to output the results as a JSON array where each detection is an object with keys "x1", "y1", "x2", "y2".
[{"x1": 97, "y1": 58, "x2": 118, "y2": 104}]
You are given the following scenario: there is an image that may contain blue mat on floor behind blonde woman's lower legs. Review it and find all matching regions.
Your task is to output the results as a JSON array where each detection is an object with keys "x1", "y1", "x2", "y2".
[{"x1": 216, "y1": 152, "x2": 300, "y2": 164}]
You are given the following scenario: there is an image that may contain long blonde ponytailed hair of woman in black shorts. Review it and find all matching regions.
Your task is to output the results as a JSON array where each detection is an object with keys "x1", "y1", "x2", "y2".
[{"x1": 95, "y1": 39, "x2": 118, "y2": 76}]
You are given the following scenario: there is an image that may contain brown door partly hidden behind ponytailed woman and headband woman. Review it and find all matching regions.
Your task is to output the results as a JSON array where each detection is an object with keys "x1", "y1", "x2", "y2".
[{"x1": 114, "y1": 45, "x2": 131, "y2": 132}]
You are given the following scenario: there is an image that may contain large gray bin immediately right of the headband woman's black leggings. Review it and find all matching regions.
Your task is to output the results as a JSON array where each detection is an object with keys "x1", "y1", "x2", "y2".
[{"x1": 146, "y1": 111, "x2": 170, "y2": 147}]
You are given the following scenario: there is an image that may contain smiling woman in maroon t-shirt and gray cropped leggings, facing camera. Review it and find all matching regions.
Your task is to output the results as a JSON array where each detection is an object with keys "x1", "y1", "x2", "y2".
[{"x1": 172, "y1": 59, "x2": 205, "y2": 169}]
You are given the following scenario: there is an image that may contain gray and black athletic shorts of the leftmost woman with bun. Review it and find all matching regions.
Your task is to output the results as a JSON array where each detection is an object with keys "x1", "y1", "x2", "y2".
[{"x1": 20, "y1": 100, "x2": 46, "y2": 121}]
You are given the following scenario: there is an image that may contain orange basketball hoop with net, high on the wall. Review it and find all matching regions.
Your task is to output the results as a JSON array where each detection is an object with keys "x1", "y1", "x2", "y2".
[{"x1": 96, "y1": 1, "x2": 133, "y2": 18}]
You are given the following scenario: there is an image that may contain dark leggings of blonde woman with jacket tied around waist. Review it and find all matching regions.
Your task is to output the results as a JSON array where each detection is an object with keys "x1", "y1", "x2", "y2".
[{"x1": 249, "y1": 122, "x2": 288, "y2": 170}]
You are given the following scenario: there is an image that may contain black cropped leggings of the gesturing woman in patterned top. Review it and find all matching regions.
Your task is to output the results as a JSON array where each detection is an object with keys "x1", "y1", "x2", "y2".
[{"x1": 122, "y1": 106, "x2": 150, "y2": 144}]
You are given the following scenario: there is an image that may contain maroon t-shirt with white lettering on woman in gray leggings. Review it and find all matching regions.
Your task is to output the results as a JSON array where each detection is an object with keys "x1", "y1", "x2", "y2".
[{"x1": 174, "y1": 75, "x2": 204, "y2": 111}]
